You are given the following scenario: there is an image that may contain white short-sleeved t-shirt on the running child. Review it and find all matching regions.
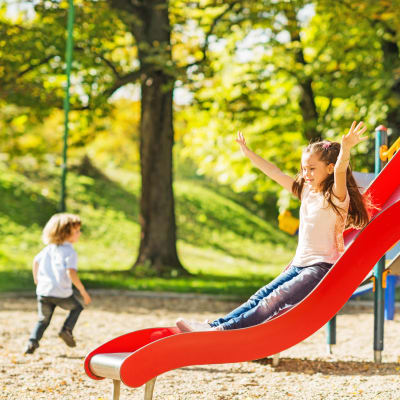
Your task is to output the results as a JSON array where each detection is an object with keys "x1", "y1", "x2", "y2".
[{"x1": 34, "y1": 242, "x2": 78, "y2": 298}]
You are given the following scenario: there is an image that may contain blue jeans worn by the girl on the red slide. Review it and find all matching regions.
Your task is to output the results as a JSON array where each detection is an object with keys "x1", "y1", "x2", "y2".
[{"x1": 210, "y1": 263, "x2": 332, "y2": 330}]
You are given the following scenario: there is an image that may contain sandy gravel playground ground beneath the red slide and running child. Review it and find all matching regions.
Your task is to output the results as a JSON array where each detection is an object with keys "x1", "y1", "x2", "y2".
[{"x1": 0, "y1": 292, "x2": 400, "y2": 400}]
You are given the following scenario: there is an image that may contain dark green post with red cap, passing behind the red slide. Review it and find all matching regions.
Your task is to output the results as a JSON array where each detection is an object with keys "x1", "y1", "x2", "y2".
[{"x1": 374, "y1": 125, "x2": 387, "y2": 363}]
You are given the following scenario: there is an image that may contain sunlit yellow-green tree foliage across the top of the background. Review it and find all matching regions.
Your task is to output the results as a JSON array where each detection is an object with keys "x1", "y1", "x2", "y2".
[{"x1": 0, "y1": 0, "x2": 394, "y2": 184}]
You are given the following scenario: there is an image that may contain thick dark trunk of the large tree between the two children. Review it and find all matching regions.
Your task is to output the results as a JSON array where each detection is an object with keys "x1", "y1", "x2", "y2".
[{"x1": 111, "y1": 0, "x2": 187, "y2": 276}]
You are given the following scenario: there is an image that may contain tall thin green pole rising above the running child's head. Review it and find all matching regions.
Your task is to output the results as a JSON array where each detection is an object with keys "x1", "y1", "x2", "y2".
[{"x1": 60, "y1": 0, "x2": 74, "y2": 212}]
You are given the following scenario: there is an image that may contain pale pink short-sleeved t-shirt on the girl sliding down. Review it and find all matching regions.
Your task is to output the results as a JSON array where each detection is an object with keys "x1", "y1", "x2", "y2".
[{"x1": 292, "y1": 184, "x2": 350, "y2": 267}]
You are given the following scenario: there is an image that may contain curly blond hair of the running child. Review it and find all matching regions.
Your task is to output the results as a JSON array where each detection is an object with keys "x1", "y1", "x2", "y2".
[{"x1": 42, "y1": 213, "x2": 82, "y2": 244}]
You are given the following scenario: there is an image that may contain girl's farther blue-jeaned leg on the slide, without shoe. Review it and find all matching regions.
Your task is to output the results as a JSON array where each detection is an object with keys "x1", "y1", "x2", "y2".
[{"x1": 210, "y1": 266, "x2": 300, "y2": 327}]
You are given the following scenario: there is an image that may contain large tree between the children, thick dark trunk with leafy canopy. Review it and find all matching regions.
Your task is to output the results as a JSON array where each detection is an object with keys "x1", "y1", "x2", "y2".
[{"x1": 0, "y1": 0, "x2": 244, "y2": 274}]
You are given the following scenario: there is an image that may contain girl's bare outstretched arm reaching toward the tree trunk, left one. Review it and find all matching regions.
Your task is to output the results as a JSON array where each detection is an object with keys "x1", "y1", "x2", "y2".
[{"x1": 236, "y1": 132, "x2": 294, "y2": 193}]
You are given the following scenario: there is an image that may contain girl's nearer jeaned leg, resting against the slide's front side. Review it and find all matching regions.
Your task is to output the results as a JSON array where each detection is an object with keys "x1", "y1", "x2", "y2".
[{"x1": 222, "y1": 263, "x2": 331, "y2": 330}]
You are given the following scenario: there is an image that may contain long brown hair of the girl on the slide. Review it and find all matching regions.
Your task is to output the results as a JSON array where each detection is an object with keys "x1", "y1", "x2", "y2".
[{"x1": 292, "y1": 140, "x2": 370, "y2": 229}]
